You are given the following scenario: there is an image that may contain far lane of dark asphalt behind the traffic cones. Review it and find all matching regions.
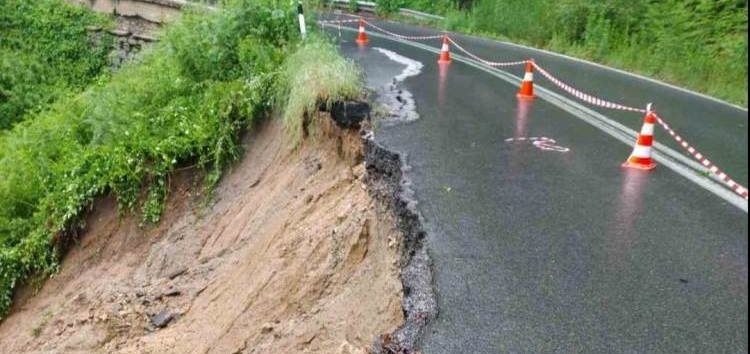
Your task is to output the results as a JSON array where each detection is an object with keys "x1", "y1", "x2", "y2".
[{"x1": 332, "y1": 16, "x2": 748, "y2": 185}]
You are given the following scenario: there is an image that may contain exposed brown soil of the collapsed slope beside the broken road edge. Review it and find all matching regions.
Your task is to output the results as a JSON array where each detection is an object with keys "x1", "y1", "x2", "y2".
[{"x1": 0, "y1": 119, "x2": 403, "y2": 353}]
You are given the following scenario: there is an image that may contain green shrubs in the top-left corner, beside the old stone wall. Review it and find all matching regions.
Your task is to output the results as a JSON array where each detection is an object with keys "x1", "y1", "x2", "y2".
[{"x1": 0, "y1": 0, "x2": 111, "y2": 130}]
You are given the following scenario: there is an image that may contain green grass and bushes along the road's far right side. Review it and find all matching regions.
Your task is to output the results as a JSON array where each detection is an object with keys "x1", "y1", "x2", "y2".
[{"x1": 378, "y1": 0, "x2": 748, "y2": 106}]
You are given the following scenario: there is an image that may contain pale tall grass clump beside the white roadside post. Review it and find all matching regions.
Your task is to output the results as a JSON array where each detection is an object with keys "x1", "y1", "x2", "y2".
[{"x1": 279, "y1": 36, "x2": 362, "y2": 144}]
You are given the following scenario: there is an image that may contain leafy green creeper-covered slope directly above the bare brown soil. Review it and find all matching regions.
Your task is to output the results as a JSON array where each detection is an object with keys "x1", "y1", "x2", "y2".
[{"x1": 0, "y1": 0, "x2": 357, "y2": 318}]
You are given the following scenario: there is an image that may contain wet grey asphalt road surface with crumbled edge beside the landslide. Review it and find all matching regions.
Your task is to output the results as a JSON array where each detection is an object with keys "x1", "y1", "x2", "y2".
[{"x1": 328, "y1": 20, "x2": 748, "y2": 353}]
